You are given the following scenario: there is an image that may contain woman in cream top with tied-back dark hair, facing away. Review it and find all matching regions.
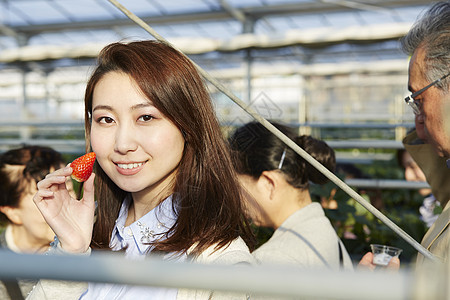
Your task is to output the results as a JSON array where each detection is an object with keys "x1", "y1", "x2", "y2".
[{"x1": 230, "y1": 122, "x2": 352, "y2": 270}]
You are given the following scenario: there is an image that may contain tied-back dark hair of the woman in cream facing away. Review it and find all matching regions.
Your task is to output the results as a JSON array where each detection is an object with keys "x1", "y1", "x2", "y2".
[{"x1": 229, "y1": 122, "x2": 336, "y2": 188}]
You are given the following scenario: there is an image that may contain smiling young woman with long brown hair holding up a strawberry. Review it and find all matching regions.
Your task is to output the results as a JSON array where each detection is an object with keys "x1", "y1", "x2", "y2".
[{"x1": 34, "y1": 41, "x2": 253, "y2": 299}]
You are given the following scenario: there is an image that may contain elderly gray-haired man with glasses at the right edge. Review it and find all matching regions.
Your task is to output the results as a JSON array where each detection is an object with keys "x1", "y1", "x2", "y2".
[{"x1": 359, "y1": 1, "x2": 450, "y2": 299}]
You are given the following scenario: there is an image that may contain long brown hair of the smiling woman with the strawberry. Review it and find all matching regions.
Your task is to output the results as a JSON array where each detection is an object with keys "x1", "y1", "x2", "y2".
[{"x1": 85, "y1": 41, "x2": 254, "y2": 255}]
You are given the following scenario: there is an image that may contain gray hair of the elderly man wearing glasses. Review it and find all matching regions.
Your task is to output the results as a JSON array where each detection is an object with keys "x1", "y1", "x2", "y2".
[{"x1": 401, "y1": 1, "x2": 450, "y2": 92}]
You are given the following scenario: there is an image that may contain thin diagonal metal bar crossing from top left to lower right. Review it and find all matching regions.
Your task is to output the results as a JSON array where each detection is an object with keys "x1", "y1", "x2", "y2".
[{"x1": 108, "y1": 0, "x2": 439, "y2": 262}]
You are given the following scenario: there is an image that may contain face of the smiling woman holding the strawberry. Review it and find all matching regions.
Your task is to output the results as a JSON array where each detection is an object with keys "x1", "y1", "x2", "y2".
[{"x1": 91, "y1": 72, "x2": 185, "y2": 196}]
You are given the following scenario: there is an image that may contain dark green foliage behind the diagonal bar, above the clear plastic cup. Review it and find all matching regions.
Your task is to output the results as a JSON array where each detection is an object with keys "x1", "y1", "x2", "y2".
[{"x1": 311, "y1": 161, "x2": 427, "y2": 266}]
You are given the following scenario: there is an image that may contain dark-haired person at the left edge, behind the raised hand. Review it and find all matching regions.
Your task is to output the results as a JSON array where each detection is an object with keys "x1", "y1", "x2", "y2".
[{"x1": 0, "y1": 146, "x2": 72, "y2": 299}]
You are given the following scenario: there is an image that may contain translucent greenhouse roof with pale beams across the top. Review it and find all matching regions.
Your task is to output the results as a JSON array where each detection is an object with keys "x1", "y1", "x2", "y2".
[{"x1": 0, "y1": 0, "x2": 429, "y2": 64}]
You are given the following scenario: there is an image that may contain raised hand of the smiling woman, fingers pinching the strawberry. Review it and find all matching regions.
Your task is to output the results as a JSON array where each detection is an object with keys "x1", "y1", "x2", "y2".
[{"x1": 33, "y1": 166, "x2": 95, "y2": 253}]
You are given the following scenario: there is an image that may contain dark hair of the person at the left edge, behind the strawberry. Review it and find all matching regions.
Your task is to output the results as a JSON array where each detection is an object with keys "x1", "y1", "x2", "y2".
[{"x1": 0, "y1": 146, "x2": 64, "y2": 223}]
